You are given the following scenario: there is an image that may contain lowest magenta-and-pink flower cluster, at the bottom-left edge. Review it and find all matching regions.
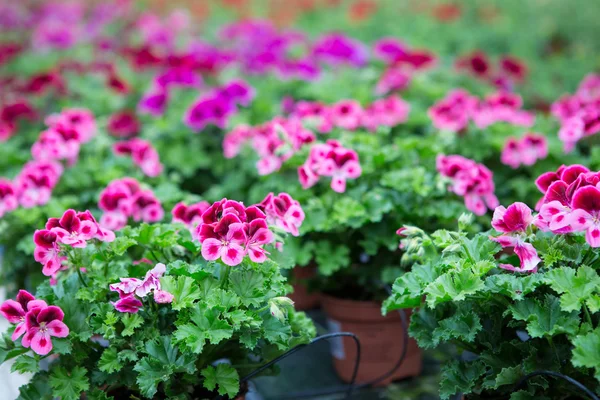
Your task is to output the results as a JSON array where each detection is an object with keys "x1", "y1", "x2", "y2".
[{"x1": 0, "y1": 290, "x2": 69, "y2": 356}]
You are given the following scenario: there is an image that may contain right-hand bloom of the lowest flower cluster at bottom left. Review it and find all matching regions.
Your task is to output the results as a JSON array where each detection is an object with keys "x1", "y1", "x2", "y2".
[{"x1": 21, "y1": 306, "x2": 69, "y2": 356}]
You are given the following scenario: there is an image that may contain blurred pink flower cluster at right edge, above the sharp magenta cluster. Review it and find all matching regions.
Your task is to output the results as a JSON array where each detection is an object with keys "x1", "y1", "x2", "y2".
[{"x1": 551, "y1": 74, "x2": 600, "y2": 152}]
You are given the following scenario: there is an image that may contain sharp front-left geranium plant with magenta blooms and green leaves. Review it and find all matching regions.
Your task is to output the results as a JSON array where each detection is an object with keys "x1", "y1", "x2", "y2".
[{"x1": 0, "y1": 199, "x2": 315, "y2": 400}]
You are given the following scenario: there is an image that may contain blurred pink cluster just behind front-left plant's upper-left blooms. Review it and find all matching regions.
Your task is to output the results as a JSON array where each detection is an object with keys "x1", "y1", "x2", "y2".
[{"x1": 98, "y1": 178, "x2": 164, "y2": 230}]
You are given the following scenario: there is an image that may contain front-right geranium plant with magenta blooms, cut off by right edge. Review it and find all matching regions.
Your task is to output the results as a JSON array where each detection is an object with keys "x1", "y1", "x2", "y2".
[{"x1": 383, "y1": 165, "x2": 600, "y2": 399}]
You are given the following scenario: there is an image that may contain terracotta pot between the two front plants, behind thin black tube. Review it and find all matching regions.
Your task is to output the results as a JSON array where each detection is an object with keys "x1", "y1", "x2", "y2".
[{"x1": 322, "y1": 295, "x2": 423, "y2": 386}]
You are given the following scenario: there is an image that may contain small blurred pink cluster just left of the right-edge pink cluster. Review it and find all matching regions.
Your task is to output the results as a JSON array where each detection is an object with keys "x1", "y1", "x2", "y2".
[{"x1": 500, "y1": 133, "x2": 548, "y2": 168}]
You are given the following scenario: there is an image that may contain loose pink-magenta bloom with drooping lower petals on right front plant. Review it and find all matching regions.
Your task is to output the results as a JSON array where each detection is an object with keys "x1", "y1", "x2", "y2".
[{"x1": 490, "y1": 203, "x2": 541, "y2": 272}]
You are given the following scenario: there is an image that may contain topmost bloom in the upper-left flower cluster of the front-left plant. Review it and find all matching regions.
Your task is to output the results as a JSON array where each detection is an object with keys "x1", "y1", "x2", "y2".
[{"x1": 46, "y1": 210, "x2": 98, "y2": 248}]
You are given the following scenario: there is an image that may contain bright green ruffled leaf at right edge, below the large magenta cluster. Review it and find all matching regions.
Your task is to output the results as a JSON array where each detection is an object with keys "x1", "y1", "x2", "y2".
[{"x1": 546, "y1": 265, "x2": 600, "y2": 311}]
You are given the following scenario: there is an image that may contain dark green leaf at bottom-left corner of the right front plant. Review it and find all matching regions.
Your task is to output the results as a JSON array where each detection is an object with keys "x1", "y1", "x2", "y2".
[{"x1": 440, "y1": 361, "x2": 485, "y2": 400}]
